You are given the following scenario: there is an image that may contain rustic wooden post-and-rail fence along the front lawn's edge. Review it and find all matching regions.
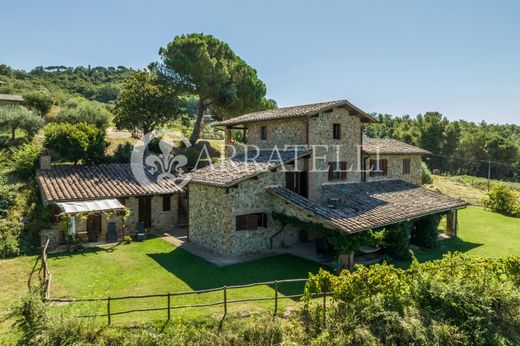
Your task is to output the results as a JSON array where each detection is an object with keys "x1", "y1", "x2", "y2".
[{"x1": 45, "y1": 279, "x2": 329, "y2": 325}]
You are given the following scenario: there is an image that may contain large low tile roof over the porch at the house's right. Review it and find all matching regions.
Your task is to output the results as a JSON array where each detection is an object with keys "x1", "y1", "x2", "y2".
[{"x1": 268, "y1": 180, "x2": 468, "y2": 233}]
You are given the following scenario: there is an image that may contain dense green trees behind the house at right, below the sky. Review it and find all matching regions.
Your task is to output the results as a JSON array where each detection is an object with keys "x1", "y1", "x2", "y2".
[{"x1": 365, "y1": 112, "x2": 520, "y2": 181}]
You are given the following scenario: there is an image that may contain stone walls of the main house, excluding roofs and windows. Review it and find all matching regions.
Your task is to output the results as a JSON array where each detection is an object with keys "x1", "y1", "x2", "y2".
[{"x1": 188, "y1": 108, "x2": 421, "y2": 255}]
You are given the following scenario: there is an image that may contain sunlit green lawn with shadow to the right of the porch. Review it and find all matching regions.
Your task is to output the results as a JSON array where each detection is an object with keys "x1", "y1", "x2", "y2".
[{"x1": 415, "y1": 207, "x2": 520, "y2": 262}]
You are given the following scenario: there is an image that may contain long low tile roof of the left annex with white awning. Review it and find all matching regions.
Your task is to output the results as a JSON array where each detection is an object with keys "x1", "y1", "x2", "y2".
[{"x1": 37, "y1": 164, "x2": 179, "y2": 202}]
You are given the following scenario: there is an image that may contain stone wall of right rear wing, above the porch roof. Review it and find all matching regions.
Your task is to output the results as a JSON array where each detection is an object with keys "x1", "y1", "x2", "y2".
[{"x1": 366, "y1": 155, "x2": 422, "y2": 185}]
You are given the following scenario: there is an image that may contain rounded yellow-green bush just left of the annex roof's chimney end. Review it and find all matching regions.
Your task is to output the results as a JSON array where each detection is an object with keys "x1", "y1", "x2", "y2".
[{"x1": 10, "y1": 142, "x2": 43, "y2": 180}]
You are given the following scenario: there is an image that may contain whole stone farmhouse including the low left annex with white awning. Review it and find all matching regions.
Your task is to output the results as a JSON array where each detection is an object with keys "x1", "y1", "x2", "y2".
[{"x1": 38, "y1": 100, "x2": 467, "y2": 264}]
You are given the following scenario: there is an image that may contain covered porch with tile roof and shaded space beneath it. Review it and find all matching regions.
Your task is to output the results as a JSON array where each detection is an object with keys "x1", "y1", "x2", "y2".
[{"x1": 268, "y1": 180, "x2": 468, "y2": 267}]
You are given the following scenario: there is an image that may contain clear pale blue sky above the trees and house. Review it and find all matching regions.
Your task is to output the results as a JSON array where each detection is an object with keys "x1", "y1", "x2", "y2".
[{"x1": 0, "y1": 0, "x2": 520, "y2": 124}]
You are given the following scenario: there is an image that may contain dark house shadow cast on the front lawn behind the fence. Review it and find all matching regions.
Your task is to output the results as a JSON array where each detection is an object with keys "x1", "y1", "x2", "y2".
[{"x1": 148, "y1": 248, "x2": 320, "y2": 295}]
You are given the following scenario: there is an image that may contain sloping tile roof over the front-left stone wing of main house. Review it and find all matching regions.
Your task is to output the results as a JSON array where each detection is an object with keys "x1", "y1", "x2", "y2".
[{"x1": 183, "y1": 148, "x2": 311, "y2": 187}]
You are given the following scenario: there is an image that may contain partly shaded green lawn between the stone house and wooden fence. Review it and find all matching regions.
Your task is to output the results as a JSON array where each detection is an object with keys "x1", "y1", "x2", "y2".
[{"x1": 49, "y1": 238, "x2": 319, "y2": 322}]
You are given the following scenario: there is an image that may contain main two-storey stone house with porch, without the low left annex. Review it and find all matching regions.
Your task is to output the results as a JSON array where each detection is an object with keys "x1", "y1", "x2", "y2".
[{"x1": 187, "y1": 100, "x2": 467, "y2": 255}]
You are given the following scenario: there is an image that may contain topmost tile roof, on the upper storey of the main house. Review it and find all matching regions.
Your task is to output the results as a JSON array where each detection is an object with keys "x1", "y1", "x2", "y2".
[{"x1": 214, "y1": 100, "x2": 376, "y2": 126}]
